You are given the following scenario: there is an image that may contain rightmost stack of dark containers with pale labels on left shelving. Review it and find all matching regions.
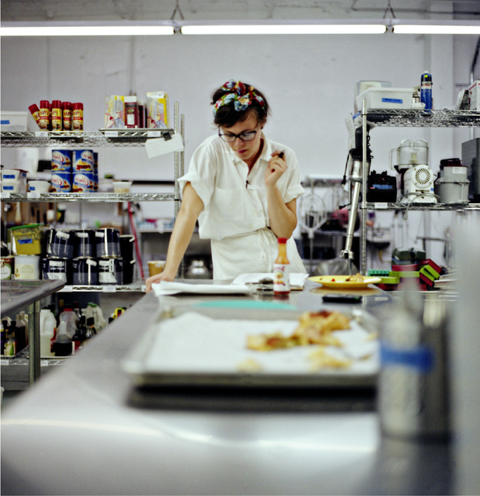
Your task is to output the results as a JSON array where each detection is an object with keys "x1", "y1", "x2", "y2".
[{"x1": 95, "y1": 228, "x2": 123, "y2": 284}]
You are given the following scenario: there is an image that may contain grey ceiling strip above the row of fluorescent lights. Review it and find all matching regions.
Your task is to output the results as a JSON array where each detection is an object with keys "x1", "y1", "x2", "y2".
[{"x1": 1, "y1": 0, "x2": 480, "y2": 22}]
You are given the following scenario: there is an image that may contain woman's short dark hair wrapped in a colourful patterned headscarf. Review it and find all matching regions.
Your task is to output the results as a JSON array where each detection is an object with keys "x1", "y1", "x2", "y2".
[{"x1": 211, "y1": 80, "x2": 270, "y2": 127}]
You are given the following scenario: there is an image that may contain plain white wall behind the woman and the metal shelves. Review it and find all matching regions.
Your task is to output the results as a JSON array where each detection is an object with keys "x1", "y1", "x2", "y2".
[{"x1": 1, "y1": 34, "x2": 476, "y2": 266}]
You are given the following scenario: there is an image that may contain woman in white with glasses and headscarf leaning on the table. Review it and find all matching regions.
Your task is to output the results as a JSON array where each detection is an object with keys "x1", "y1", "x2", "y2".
[{"x1": 146, "y1": 80, "x2": 305, "y2": 292}]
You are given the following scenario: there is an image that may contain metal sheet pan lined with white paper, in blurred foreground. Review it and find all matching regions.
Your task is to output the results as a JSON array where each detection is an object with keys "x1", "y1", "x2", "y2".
[{"x1": 124, "y1": 308, "x2": 379, "y2": 387}]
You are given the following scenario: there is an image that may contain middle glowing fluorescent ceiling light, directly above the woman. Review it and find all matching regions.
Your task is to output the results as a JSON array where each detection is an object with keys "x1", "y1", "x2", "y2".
[{"x1": 181, "y1": 23, "x2": 386, "y2": 35}]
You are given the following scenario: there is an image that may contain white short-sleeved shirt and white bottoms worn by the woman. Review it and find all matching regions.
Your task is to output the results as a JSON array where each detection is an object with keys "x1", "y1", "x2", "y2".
[{"x1": 179, "y1": 135, "x2": 304, "y2": 279}]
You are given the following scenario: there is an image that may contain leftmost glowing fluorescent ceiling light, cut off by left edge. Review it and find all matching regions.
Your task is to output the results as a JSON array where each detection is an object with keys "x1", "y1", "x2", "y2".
[{"x1": 0, "y1": 23, "x2": 174, "y2": 37}]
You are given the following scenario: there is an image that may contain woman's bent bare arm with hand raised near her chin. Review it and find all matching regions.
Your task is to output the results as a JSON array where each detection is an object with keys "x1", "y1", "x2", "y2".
[{"x1": 265, "y1": 151, "x2": 297, "y2": 238}]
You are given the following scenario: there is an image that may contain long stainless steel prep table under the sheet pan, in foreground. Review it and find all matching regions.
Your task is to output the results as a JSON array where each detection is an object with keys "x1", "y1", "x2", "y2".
[{"x1": 2, "y1": 282, "x2": 454, "y2": 495}]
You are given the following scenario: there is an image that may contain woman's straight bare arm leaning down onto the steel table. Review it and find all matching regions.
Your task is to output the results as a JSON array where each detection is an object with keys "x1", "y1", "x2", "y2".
[{"x1": 146, "y1": 183, "x2": 203, "y2": 293}]
